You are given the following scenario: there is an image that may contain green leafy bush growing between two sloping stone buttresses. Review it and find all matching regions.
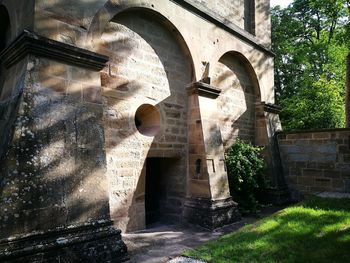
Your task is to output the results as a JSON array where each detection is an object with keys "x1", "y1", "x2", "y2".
[{"x1": 225, "y1": 140, "x2": 265, "y2": 213}]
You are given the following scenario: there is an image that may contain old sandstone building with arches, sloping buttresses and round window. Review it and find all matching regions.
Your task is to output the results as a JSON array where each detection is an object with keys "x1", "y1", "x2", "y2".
[{"x1": 0, "y1": 0, "x2": 279, "y2": 262}]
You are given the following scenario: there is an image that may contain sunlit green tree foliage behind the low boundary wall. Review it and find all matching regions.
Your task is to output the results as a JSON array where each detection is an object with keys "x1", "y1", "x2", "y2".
[{"x1": 272, "y1": 0, "x2": 348, "y2": 130}]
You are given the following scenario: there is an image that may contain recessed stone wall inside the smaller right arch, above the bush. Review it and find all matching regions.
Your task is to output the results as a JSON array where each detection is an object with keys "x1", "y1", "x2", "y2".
[{"x1": 212, "y1": 51, "x2": 261, "y2": 148}]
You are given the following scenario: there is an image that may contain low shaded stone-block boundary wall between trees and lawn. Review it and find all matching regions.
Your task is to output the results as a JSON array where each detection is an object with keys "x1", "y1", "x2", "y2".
[{"x1": 278, "y1": 129, "x2": 350, "y2": 198}]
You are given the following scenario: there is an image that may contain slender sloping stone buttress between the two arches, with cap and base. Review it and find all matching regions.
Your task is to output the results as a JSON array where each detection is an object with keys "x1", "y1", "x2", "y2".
[{"x1": 184, "y1": 82, "x2": 239, "y2": 229}]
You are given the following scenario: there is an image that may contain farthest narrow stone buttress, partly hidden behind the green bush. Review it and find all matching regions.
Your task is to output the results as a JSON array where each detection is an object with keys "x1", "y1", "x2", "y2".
[{"x1": 255, "y1": 102, "x2": 290, "y2": 204}]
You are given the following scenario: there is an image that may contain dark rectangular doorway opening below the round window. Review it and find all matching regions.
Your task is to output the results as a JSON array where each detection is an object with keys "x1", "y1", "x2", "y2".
[{"x1": 145, "y1": 158, "x2": 186, "y2": 227}]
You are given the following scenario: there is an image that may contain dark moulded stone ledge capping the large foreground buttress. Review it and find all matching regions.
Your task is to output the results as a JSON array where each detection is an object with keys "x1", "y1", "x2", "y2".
[{"x1": 0, "y1": 30, "x2": 108, "y2": 71}]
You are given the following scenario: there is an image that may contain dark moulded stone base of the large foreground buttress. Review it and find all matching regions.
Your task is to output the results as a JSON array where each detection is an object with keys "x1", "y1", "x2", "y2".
[{"x1": 0, "y1": 220, "x2": 127, "y2": 262}]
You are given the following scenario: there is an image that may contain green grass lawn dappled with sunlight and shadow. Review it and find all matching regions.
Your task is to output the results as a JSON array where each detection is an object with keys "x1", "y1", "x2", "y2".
[{"x1": 184, "y1": 198, "x2": 350, "y2": 263}]
